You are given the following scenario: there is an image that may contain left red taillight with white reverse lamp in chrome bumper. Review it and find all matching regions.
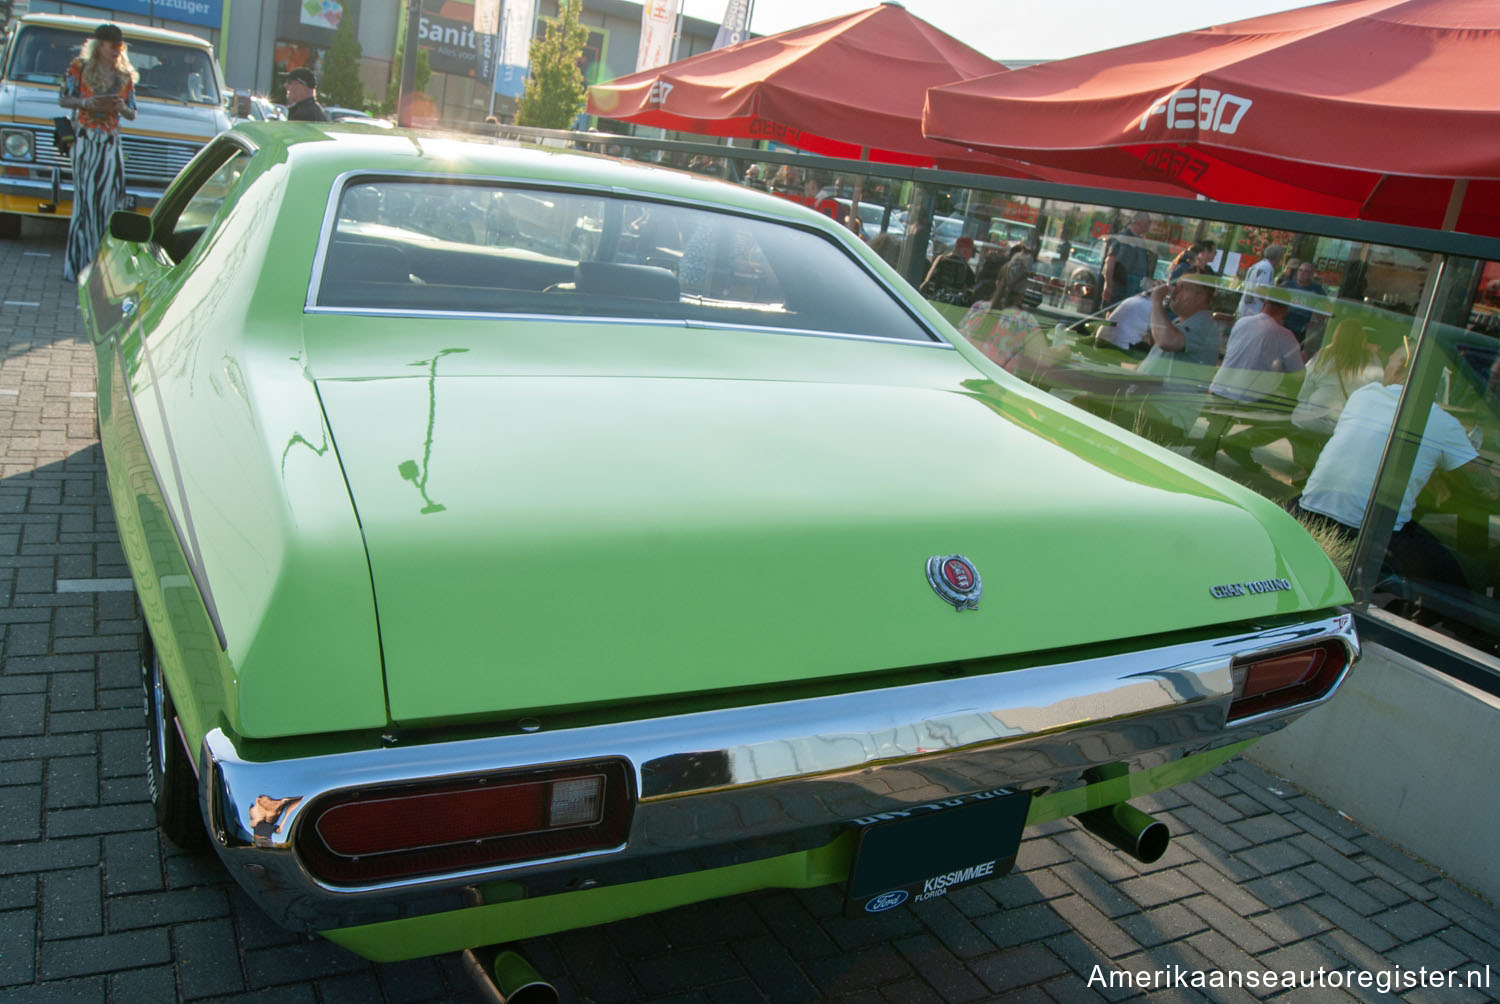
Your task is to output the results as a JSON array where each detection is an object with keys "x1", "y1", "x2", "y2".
[{"x1": 297, "y1": 761, "x2": 632, "y2": 884}]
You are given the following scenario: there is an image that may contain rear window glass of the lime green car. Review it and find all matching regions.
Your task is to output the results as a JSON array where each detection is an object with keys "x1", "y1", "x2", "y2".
[{"x1": 315, "y1": 180, "x2": 935, "y2": 342}]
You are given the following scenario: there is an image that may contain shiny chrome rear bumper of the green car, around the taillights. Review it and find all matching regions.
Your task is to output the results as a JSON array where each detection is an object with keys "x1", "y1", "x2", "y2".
[{"x1": 200, "y1": 614, "x2": 1359, "y2": 930}]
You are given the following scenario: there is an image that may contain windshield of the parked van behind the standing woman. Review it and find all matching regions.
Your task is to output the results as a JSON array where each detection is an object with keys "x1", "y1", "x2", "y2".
[{"x1": 5, "y1": 26, "x2": 221, "y2": 105}]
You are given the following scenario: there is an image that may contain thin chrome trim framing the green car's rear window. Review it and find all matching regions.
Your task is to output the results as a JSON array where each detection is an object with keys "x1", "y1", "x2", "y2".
[{"x1": 303, "y1": 168, "x2": 953, "y2": 348}]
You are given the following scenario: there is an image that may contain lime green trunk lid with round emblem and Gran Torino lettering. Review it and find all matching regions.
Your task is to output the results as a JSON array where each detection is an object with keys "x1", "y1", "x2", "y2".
[{"x1": 318, "y1": 359, "x2": 1337, "y2": 722}]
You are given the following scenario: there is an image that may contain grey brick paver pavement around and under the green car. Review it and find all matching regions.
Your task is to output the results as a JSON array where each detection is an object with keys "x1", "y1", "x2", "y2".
[{"x1": 0, "y1": 222, "x2": 1500, "y2": 1004}]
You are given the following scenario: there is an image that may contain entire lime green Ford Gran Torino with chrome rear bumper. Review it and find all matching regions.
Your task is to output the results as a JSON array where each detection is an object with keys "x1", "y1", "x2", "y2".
[{"x1": 80, "y1": 123, "x2": 1358, "y2": 960}]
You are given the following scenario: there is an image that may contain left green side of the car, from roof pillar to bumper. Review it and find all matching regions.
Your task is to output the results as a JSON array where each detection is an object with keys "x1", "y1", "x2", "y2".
[{"x1": 83, "y1": 150, "x2": 386, "y2": 746}]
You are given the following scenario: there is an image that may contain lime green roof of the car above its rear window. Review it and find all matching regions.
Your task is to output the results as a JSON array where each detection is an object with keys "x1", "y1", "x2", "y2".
[{"x1": 234, "y1": 122, "x2": 845, "y2": 225}]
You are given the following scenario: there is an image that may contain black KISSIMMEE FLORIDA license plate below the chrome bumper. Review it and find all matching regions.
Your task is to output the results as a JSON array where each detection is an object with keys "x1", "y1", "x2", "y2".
[{"x1": 845, "y1": 788, "x2": 1031, "y2": 917}]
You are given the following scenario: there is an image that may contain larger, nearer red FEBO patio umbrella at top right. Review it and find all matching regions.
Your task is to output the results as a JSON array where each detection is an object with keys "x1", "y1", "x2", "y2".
[{"x1": 923, "y1": 0, "x2": 1500, "y2": 236}]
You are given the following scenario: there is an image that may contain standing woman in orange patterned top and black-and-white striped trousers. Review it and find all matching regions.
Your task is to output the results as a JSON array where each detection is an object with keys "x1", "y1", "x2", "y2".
[{"x1": 57, "y1": 24, "x2": 137, "y2": 281}]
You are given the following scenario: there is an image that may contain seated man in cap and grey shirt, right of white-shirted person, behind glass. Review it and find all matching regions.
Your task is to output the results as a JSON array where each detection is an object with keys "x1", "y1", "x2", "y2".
[{"x1": 1137, "y1": 272, "x2": 1220, "y2": 438}]
